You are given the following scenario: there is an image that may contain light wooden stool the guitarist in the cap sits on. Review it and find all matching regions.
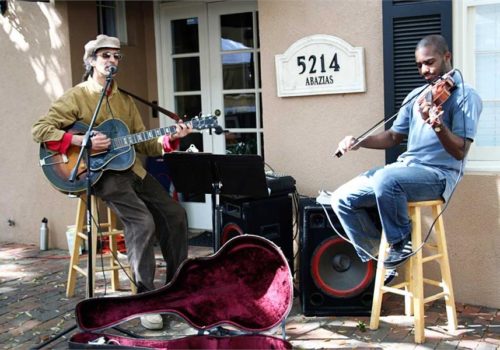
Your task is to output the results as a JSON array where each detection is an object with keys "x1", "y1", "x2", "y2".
[{"x1": 66, "y1": 196, "x2": 137, "y2": 297}]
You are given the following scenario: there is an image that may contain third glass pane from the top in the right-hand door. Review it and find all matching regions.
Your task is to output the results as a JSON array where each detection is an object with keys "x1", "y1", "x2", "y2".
[{"x1": 224, "y1": 94, "x2": 257, "y2": 129}]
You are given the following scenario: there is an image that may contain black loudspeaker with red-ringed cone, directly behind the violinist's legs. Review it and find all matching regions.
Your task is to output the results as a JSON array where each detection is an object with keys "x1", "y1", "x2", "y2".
[{"x1": 299, "y1": 198, "x2": 376, "y2": 316}]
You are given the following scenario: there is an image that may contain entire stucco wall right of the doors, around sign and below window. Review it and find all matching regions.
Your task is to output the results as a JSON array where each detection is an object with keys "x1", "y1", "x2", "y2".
[{"x1": 258, "y1": 0, "x2": 500, "y2": 307}]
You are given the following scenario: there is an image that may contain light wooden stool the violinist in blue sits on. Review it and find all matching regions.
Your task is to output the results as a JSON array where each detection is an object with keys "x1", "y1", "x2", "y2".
[{"x1": 370, "y1": 200, "x2": 457, "y2": 344}]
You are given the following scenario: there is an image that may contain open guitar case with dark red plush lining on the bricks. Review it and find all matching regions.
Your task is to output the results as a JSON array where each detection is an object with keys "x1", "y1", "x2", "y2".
[{"x1": 69, "y1": 235, "x2": 293, "y2": 349}]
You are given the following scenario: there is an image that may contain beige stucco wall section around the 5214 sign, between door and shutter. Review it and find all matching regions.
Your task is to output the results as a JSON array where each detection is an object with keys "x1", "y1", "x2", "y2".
[{"x1": 259, "y1": 0, "x2": 384, "y2": 191}]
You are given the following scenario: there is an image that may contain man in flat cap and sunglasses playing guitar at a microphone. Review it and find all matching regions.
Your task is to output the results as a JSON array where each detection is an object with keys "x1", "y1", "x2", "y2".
[{"x1": 32, "y1": 35, "x2": 192, "y2": 329}]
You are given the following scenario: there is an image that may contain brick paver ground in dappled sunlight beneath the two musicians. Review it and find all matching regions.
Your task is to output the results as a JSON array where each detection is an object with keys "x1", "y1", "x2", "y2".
[{"x1": 0, "y1": 243, "x2": 500, "y2": 349}]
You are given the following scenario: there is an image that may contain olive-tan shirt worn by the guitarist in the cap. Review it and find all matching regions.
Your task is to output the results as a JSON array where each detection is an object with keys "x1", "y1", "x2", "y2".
[{"x1": 31, "y1": 78, "x2": 162, "y2": 178}]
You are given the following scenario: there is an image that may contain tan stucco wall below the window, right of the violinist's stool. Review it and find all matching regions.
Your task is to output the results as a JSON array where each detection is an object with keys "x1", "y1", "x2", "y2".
[{"x1": 444, "y1": 175, "x2": 500, "y2": 308}]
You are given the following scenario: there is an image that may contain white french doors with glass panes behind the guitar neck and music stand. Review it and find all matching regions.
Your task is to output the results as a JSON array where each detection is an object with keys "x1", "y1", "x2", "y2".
[{"x1": 157, "y1": 1, "x2": 263, "y2": 230}]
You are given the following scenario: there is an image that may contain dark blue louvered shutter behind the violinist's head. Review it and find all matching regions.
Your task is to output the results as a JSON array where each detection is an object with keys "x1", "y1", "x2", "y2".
[{"x1": 382, "y1": 0, "x2": 452, "y2": 163}]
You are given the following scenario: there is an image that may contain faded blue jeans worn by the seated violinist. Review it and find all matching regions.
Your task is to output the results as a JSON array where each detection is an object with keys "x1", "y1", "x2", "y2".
[{"x1": 331, "y1": 163, "x2": 446, "y2": 261}]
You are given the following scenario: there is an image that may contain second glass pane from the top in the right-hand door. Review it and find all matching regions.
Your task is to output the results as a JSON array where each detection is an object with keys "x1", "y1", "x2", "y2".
[{"x1": 222, "y1": 52, "x2": 255, "y2": 90}]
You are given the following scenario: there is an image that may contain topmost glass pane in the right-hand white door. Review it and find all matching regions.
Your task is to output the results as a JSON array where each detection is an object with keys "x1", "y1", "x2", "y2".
[{"x1": 220, "y1": 12, "x2": 253, "y2": 51}]
